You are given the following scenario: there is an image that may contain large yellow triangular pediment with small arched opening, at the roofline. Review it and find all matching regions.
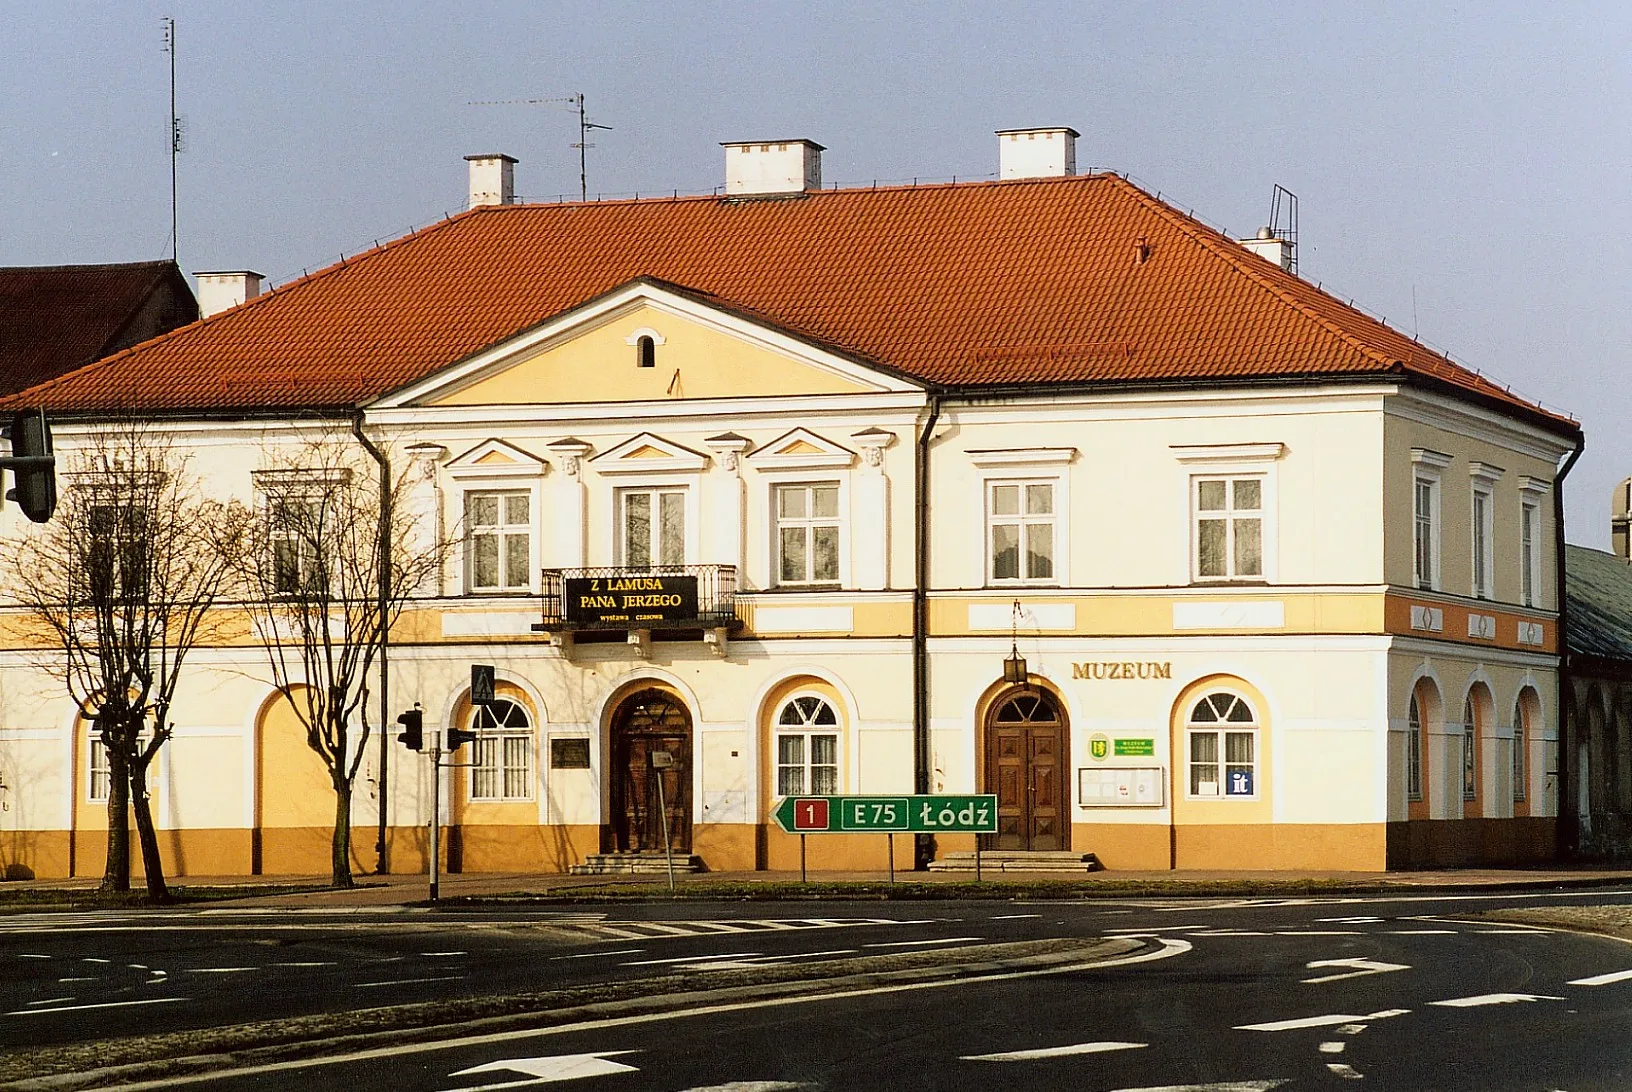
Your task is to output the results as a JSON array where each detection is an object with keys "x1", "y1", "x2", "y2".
[{"x1": 377, "y1": 281, "x2": 919, "y2": 408}]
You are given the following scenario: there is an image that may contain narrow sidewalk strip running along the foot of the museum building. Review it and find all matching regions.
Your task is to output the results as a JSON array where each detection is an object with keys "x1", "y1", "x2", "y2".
[{"x1": 12, "y1": 868, "x2": 1632, "y2": 909}]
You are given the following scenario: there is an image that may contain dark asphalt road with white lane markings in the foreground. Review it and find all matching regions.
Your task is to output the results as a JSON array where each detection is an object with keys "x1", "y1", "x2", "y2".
[{"x1": 9, "y1": 893, "x2": 1632, "y2": 1092}]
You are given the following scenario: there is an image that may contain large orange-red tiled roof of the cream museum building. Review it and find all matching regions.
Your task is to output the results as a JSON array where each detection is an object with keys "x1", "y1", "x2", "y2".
[{"x1": 6, "y1": 175, "x2": 1577, "y2": 434}]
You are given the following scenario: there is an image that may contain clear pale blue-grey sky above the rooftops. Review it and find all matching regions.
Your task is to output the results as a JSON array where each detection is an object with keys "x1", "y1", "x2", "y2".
[{"x1": 0, "y1": 0, "x2": 1632, "y2": 545}]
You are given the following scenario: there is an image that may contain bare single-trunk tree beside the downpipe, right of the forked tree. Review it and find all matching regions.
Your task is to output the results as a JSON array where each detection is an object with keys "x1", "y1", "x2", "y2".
[{"x1": 243, "y1": 433, "x2": 450, "y2": 886}]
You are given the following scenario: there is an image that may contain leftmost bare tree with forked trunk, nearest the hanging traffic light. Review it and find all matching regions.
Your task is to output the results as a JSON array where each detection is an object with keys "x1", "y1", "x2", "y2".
[{"x1": 8, "y1": 421, "x2": 248, "y2": 901}]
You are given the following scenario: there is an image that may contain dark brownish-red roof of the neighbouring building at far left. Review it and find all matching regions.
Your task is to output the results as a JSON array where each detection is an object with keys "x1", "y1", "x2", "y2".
[{"x1": 0, "y1": 261, "x2": 199, "y2": 393}]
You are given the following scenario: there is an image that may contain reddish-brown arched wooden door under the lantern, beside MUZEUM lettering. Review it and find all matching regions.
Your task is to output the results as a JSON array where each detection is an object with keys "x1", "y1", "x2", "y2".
[{"x1": 986, "y1": 690, "x2": 1071, "y2": 850}]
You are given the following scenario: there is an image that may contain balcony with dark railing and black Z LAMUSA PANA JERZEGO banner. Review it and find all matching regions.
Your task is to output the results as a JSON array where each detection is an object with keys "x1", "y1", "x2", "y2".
[{"x1": 534, "y1": 565, "x2": 743, "y2": 633}]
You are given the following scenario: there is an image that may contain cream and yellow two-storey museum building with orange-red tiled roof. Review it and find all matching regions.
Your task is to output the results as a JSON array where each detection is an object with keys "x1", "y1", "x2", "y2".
[{"x1": 0, "y1": 129, "x2": 1580, "y2": 875}]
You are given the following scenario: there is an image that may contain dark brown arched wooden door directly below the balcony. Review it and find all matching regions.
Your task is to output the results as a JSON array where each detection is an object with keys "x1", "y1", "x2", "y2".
[{"x1": 607, "y1": 689, "x2": 692, "y2": 854}]
